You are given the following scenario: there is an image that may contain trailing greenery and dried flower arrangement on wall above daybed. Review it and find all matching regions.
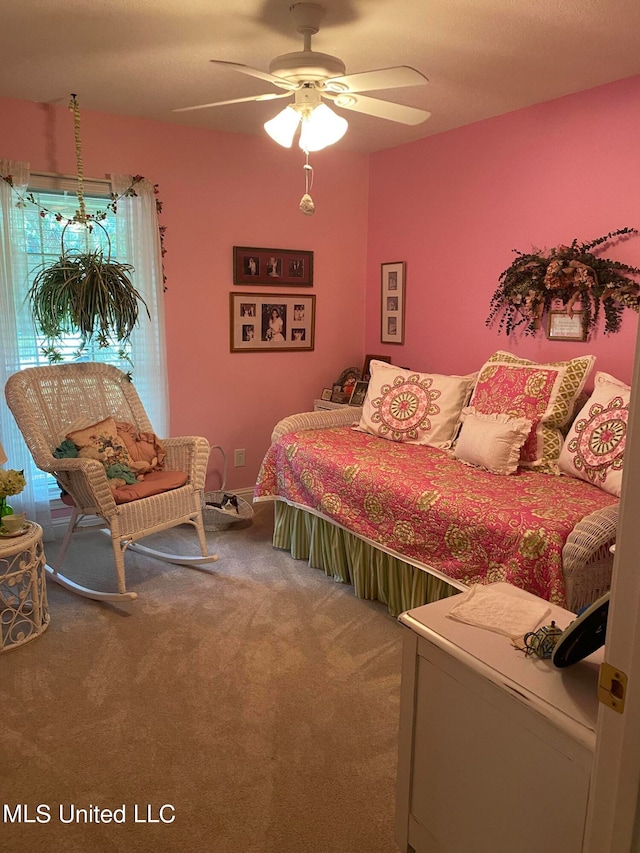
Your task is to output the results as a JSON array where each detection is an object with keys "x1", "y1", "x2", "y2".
[{"x1": 486, "y1": 228, "x2": 640, "y2": 337}]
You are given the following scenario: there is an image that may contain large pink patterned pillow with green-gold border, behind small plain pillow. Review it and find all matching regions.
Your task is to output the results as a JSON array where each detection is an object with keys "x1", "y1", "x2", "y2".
[{"x1": 470, "y1": 350, "x2": 595, "y2": 473}]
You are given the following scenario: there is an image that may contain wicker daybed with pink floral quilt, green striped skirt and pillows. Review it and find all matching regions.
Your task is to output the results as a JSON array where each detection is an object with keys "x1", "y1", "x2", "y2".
[{"x1": 254, "y1": 353, "x2": 629, "y2": 615}]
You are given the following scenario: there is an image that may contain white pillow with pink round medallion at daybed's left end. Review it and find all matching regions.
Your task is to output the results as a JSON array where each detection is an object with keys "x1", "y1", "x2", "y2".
[{"x1": 357, "y1": 360, "x2": 476, "y2": 449}]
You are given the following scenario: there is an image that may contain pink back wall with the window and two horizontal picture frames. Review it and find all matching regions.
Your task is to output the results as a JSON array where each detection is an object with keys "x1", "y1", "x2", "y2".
[{"x1": 0, "y1": 95, "x2": 368, "y2": 488}]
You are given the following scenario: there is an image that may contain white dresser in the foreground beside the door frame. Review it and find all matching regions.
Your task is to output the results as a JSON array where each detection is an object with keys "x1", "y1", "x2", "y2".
[{"x1": 396, "y1": 584, "x2": 603, "y2": 853}]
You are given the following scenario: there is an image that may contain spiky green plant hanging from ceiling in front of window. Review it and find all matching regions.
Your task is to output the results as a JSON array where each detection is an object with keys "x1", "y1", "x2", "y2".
[{"x1": 21, "y1": 95, "x2": 150, "y2": 362}]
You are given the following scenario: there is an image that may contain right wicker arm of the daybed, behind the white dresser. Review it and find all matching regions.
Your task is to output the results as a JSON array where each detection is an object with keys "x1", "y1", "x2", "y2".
[{"x1": 562, "y1": 503, "x2": 619, "y2": 611}]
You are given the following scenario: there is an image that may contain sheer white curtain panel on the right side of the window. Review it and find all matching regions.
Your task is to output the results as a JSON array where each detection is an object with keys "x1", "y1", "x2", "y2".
[{"x1": 111, "y1": 175, "x2": 169, "y2": 437}]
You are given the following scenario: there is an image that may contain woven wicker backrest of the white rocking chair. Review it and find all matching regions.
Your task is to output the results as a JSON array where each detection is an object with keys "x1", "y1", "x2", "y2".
[{"x1": 5, "y1": 362, "x2": 153, "y2": 467}]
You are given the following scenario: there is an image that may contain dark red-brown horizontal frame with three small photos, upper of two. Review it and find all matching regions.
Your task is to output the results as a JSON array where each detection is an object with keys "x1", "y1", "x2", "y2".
[{"x1": 233, "y1": 246, "x2": 313, "y2": 287}]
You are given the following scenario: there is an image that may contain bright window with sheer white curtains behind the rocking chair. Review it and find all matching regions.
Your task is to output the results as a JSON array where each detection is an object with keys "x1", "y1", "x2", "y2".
[{"x1": 0, "y1": 159, "x2": 168, "y2": 538}]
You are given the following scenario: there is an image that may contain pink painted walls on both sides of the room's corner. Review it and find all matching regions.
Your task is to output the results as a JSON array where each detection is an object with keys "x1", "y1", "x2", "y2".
[{"x1": 5, "y1": 77, "x2": 640, "y2": 488}]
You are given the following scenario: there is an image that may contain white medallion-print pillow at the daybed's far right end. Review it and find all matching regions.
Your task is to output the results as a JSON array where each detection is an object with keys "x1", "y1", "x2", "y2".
[{"x1": 559, "y1": 371, "x2": 631, "y2": 497}]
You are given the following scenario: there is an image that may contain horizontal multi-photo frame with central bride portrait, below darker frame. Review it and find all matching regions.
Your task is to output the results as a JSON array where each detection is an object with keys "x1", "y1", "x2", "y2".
[{"x1": 229, "y1": 290, "x2": 316, "y2": 352}]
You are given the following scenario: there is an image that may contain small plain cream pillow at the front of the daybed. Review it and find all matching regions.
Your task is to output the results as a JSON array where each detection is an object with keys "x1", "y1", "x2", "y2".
[{"x1": 452, "y1": 407, "x2": 531, "y2": 474}]
